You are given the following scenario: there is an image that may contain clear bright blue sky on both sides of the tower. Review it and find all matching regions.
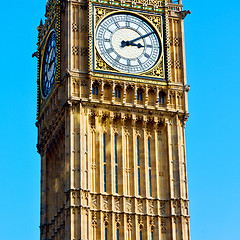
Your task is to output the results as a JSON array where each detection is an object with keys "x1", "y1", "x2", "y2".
[{"x1": 0, "y1": 0, "x2": 240, "y2": 240}]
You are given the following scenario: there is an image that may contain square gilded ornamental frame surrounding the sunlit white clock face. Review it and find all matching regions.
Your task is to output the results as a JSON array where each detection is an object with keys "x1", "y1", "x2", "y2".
[{"x1": 89, "y1": 2, "x2": 166, "y2": 82}]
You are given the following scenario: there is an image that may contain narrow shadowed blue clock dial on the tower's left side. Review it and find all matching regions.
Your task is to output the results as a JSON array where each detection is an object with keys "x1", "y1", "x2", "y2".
[{"x1": 42, "y1": 31, "x2": 57, "y2": 98}]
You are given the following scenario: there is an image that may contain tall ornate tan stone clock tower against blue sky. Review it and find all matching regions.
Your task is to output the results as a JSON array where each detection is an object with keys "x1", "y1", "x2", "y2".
[{"x1": 36, "y1": 0, "x2": 190, "y2": 240}]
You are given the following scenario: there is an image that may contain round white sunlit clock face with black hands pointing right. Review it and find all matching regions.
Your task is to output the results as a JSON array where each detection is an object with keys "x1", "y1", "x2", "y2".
[{"x1": 95, "y1": 13, "x2": 161, "y2": 74}]
